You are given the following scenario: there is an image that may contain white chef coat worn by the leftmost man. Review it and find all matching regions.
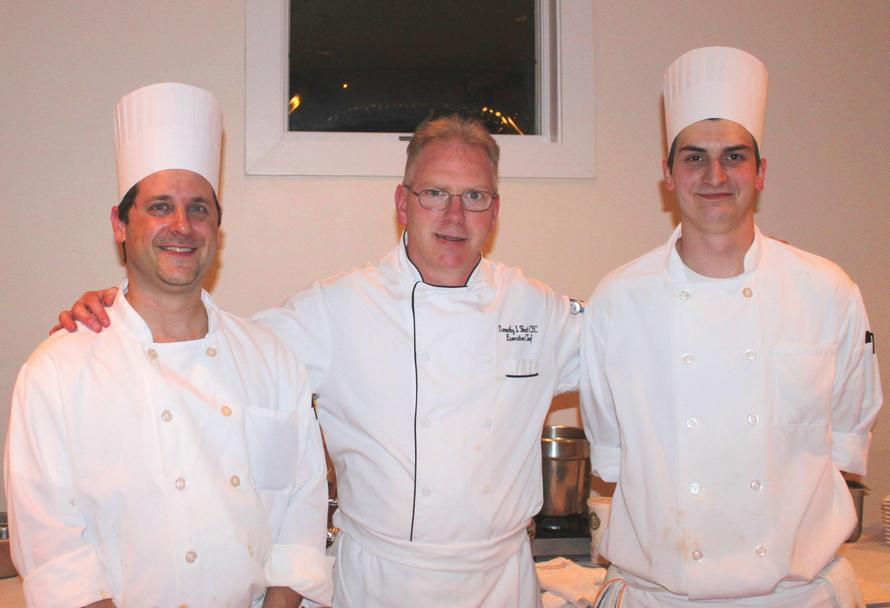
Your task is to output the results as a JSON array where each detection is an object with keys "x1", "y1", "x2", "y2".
[{"x1": 6, "y1": 283, "x2": 331, "y2": 608}]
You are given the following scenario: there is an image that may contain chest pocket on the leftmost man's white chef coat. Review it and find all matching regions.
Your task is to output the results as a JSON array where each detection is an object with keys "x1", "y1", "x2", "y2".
[{"x1": 244, "y1": 407, "x2": 299, "y2": 490}]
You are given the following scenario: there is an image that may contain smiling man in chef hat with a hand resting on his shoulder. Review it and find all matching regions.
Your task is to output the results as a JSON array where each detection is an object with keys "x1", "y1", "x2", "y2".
[{"x1": 6, "y1": 83, "x2": 331, "y2": 607}]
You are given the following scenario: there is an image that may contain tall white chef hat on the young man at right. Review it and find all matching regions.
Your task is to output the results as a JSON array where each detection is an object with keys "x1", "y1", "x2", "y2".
[{"x1": 663, "y1": 46, "x2": 767, "y2": 147}]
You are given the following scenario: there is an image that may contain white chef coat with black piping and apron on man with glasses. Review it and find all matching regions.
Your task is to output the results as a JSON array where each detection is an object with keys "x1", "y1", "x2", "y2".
[{"x1": 256, "y1": 238, "x2": 580, "y2": 608}]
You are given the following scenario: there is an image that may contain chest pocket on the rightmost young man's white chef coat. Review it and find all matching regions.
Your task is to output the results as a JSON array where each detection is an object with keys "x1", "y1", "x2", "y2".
[{"x1": 773, "y1": 344, "x2": 837, "y2": 426}]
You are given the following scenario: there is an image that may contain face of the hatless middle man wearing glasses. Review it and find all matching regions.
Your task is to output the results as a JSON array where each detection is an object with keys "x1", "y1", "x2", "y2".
[{"x1": 395, "y1": 140, "x2": 500, "y2": 286}]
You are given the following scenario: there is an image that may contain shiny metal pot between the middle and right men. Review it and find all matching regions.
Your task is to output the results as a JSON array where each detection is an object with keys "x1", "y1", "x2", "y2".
[{"x1": 541, "y1": 425, "x2": 590, "y2": 516}]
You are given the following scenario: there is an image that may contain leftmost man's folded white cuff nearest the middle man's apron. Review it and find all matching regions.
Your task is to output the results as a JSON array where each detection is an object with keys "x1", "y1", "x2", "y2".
[{"x1": 265, "y1": 545, "x2": 334, "y2": 606}]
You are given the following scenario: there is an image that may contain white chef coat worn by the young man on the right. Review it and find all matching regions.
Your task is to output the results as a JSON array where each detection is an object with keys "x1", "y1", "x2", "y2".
[{"x1": 581, "y1": 227, "x2": 881, "y2": 599}]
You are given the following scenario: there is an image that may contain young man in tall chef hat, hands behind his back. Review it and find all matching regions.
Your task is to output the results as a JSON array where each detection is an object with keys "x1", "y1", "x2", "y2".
[{"x1": 581, "y1": 47, "x2": 882, "y2": 608}]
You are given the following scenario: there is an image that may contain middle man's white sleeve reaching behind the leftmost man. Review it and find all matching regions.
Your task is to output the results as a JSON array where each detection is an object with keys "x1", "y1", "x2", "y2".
[{"x1": 253, "y1": 282, "x2": 331, "y2": 393}]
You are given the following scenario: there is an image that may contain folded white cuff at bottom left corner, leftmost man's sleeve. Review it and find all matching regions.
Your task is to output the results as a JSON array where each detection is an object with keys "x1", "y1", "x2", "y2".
[{"x1": 22, "y1": 546, "x2": 111, "y2": 608}]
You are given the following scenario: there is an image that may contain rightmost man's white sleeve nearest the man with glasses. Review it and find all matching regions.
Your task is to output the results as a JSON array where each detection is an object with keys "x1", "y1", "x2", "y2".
[{"x1": 580, "y1": 292, "x2": 621, "y2": 482}]
